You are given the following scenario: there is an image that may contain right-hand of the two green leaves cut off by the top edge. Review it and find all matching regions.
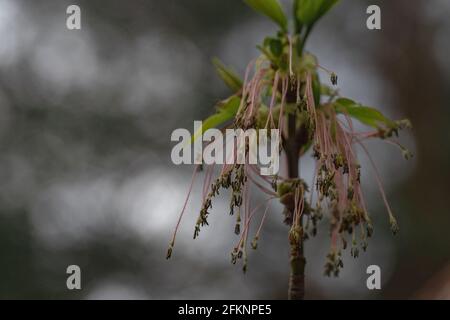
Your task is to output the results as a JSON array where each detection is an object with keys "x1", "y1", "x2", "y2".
[{"x1": 294, "y1": 0, "x2": 339, "y2": 28}]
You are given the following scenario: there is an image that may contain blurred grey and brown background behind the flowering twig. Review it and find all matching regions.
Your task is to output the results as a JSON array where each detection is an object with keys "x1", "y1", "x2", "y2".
[{"x1": 0, "y1": 0, "x2": 450, "y2": 299}]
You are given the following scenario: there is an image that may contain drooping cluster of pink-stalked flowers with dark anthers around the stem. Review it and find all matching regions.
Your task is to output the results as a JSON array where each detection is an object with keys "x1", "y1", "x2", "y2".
[{"x1": 167, "y1": 35, "x2": 410, "y2": 276}]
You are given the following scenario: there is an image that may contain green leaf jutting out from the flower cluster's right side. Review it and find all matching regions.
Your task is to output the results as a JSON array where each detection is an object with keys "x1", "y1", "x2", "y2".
[{"x1": 334, "y1": 98, "x2": 398, "y2": 129}]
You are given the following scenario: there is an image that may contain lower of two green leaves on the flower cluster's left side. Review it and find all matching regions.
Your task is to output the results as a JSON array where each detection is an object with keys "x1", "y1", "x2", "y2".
[{"x1": 191, "y1": 96, "x2": 241, "y2": 143}]
